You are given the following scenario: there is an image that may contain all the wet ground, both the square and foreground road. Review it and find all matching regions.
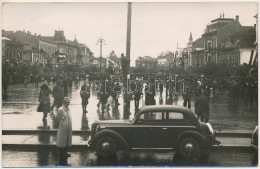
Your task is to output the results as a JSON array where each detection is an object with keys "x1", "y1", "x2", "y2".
[{"x1": 2, "y1": 81, "x2": 258, "y2": 167}]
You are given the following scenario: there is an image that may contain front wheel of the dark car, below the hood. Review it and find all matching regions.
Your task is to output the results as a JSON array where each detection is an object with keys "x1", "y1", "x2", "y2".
[{"x1": 96, "y1": 137, "x2": 117, "y2": 157}]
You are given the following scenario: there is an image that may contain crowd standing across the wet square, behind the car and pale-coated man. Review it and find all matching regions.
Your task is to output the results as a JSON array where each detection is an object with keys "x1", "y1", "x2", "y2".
[{"x1": 35, "y1": 71, "x2": 257, "y2": 125}]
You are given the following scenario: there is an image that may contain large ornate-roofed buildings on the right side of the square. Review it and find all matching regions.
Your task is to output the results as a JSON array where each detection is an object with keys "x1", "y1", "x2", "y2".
[{"x1": 187, "y1": 15, "x2": 256, "y2": 67}]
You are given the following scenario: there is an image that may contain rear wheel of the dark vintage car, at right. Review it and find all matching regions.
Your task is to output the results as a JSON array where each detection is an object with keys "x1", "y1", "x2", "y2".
[{"x1": 179, "y1": 138, "x2": 199, "y2": 159}]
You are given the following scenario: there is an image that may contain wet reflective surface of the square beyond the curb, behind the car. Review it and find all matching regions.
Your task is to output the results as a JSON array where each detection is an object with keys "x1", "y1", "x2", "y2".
[{"x1": 2, "y1": 83, "x2": 258, "y2": 131}]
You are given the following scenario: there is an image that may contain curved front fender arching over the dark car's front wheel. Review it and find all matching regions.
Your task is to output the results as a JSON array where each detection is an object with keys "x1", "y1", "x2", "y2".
[{"x1": 91, "y1": 129, "x2": 130, "y2": 150}]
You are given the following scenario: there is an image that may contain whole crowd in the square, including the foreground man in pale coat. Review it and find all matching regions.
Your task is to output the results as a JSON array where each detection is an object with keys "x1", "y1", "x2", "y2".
[{"x1": 3, "y1": 68, "x2": 258, "y2": 165}]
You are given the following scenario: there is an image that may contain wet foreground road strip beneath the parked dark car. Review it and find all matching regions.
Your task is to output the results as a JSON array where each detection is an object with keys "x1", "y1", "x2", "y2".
[{"x1": 2, "y1": 148, "x2": 255, "y2": 167}]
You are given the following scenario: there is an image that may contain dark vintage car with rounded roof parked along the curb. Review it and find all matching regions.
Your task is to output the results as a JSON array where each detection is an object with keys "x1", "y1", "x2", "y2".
[{"x1": 89, "y1": 105, "x2": 219, "y2": 158}]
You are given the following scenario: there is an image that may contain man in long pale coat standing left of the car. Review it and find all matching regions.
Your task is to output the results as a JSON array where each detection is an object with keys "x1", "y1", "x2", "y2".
[{"x1": 56, "y1": 97, "x2": 72, "y2": 165}]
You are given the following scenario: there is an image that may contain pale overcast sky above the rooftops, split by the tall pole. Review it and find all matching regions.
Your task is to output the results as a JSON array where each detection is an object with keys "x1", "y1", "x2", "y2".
[{"x1": 2, "y1": 2, "x2": 258, "y2": 65}]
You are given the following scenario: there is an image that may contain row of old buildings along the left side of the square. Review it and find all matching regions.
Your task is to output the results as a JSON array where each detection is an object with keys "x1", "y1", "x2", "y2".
[{"x1": 2, "y1": 30, "x2": 93, "y2": 66}]
